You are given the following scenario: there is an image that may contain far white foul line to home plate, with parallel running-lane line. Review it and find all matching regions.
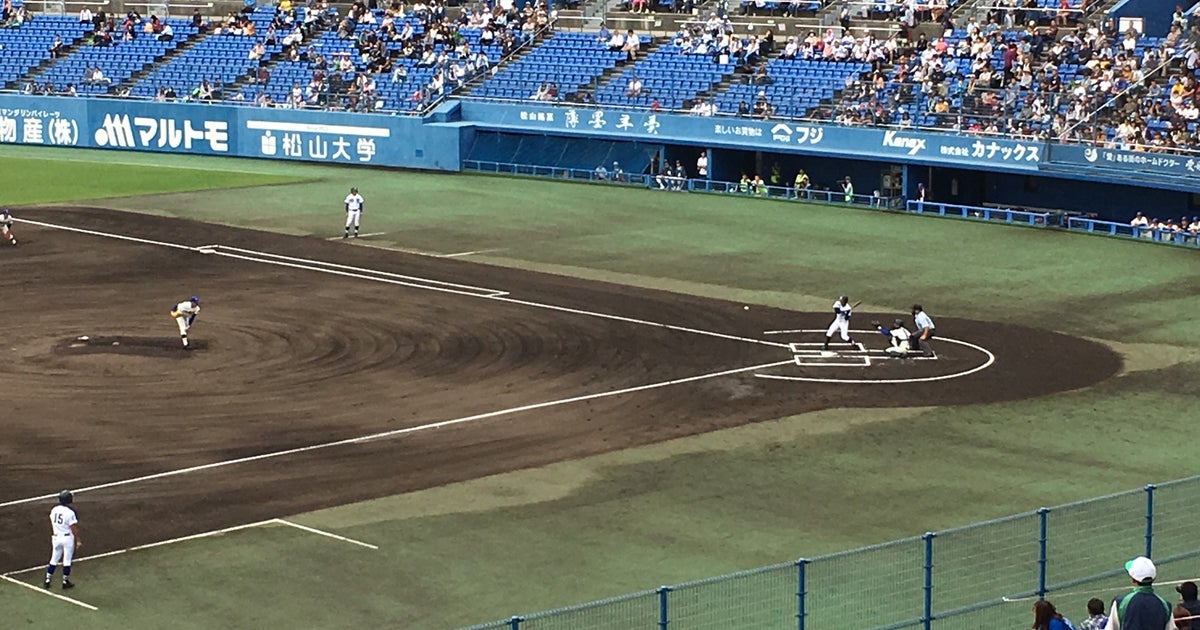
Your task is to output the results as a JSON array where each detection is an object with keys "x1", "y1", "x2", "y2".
[{"x1": 19, "y1": 220, "x2": 788, "y2": 348}]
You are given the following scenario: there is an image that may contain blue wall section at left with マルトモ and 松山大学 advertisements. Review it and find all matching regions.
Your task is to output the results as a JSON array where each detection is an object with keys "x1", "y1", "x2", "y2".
[{"x1": 0, "y1": 95, "x2": 462, "y2": 170}]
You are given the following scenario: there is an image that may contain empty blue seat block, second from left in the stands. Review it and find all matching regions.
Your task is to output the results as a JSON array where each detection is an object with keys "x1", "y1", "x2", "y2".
[{"x1": 36, "y1": 19, "x2": 196, "y2": 95}]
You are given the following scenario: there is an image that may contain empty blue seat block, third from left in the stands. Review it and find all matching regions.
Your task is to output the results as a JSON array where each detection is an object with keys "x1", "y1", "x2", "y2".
[{"x1": 131, "y1": 8, "x2": 283, "y2": 97}]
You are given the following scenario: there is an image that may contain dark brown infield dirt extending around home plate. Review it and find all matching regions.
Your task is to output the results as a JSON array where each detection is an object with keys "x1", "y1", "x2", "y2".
[{"x1": 0, "y1": 209, "x2": 1121, "y2": 571}]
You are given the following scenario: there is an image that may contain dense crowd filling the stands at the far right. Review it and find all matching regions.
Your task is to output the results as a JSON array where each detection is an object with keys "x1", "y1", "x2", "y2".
[{"x1": 825, "y1": 8, "x2": 1200, "y2": 151}]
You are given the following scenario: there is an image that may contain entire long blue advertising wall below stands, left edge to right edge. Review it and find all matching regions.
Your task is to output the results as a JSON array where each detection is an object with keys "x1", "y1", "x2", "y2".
[{"x1": 7, "y1": 95, "x2": 1200, "y2": 201}]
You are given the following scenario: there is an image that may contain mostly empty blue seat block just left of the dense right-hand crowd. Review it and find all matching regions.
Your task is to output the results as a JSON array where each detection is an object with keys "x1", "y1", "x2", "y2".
[{"x1": 716, "y1": 59, "x2": 871, "y2": 116}]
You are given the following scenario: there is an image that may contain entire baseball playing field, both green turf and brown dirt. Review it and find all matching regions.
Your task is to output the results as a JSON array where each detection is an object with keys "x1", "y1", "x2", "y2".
[{"x1": 0, "y1": 146, "x2": 1200, "y2": 629}]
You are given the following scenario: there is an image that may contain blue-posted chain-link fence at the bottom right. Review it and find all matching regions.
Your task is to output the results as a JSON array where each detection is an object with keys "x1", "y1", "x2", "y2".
[{"x1": 458, "y1": 476, "x2": 1200, "y2": 630}]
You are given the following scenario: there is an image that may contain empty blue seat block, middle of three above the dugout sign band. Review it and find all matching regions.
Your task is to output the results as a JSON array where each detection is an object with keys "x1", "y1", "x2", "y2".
[{"x1": 595, "y1": 44, "x2": 736, "y2": 109}]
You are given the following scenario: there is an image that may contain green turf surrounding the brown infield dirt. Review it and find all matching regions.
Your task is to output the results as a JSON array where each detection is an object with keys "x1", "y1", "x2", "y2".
[{"x1": 0, "y1": 148, "x2": 1200, "y2": 628}]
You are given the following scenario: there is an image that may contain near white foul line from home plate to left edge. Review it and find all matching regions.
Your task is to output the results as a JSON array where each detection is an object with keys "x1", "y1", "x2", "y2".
[{"x1": 0, "y1": 359, "x2": 792, "y2": 508}]
